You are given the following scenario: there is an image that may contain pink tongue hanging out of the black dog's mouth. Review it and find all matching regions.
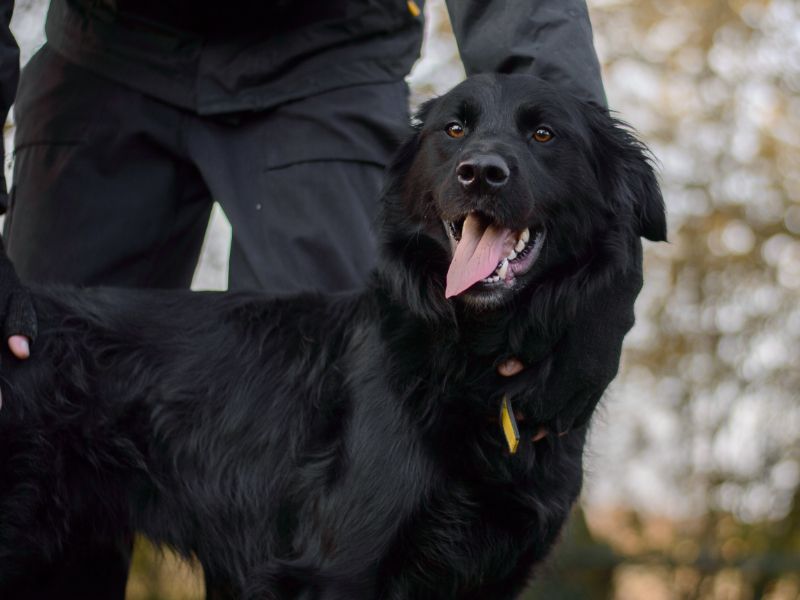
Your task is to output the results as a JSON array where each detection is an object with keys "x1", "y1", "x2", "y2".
[{"x1": 444, "y1": 213, "x2": 515, "y2": 298}]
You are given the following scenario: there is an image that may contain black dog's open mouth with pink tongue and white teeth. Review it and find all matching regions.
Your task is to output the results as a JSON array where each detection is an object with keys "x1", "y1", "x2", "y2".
[{"x1": 444, "y1": 212, "x2": 545, "y2": 298}]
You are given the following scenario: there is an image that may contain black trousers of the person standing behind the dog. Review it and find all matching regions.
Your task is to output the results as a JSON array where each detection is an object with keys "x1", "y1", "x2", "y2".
[{"x1": 5, "y1": 46, "x2": 408, "y2": 600}]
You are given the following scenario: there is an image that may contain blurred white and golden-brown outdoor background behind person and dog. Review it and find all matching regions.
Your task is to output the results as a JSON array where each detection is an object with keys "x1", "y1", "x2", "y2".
[{"x1": 6, "y1": 0, "x2": 800, "y2": 600}]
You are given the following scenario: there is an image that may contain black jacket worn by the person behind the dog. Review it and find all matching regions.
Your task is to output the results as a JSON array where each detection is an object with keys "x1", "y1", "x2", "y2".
[{"x1": 0, "y1": 0, "x2": 605, "y2": 204}]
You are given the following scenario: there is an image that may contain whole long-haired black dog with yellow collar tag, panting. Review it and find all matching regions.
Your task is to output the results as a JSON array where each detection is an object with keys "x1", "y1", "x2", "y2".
[{"x1": 0, "y1": 76, "x2": 665, "y2": 600}]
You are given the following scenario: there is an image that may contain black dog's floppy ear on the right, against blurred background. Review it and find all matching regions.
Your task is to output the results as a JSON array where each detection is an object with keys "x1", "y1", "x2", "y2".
[{"x1": 589, "y1": 106, "x2": 667, "y2": 242}]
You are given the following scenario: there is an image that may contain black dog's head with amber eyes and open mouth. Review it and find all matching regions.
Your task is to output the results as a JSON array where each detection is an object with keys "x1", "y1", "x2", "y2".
[{"x1": 383, "y1": 75, "x2": 666, "y2": 315}]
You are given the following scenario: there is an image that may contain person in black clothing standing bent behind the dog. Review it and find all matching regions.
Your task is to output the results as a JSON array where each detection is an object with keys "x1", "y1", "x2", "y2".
[{"x1": 0, "y1": 0, "x2": 616, "y2": 599}]
